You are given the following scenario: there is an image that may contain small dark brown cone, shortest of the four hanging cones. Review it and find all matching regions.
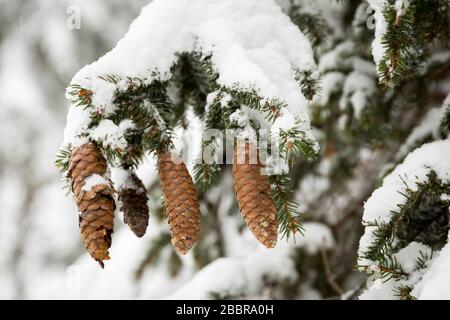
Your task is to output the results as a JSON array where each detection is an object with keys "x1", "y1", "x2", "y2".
[{"x1": 119, "y1": 172, "x2": 149, "y2": 238}]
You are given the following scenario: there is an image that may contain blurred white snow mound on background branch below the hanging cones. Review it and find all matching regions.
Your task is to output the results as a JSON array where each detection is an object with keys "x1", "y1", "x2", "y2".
[{"x1": 167, "y1": 222, "x2": 335, "y2": 300}]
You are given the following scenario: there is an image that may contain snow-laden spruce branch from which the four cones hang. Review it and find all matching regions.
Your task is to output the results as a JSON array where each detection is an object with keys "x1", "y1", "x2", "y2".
[{"x1": 58, "y1": 0, "x2": 319, "y2": 246}]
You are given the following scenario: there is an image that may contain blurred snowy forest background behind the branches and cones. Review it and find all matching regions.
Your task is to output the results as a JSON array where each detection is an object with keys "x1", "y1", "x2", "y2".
[{"x1": 0, "y1": 0, "x2": 450, "y2": 299}]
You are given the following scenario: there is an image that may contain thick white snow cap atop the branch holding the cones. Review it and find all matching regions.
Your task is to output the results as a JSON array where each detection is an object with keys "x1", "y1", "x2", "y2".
[{"x1": 65, "y1": 0, "x2": 316, "y2": 156}]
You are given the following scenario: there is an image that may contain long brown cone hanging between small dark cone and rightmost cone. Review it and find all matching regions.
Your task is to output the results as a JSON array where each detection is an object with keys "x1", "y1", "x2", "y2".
[{"x1": 158, "y1": 152, "x2": 200, "y2": 254}]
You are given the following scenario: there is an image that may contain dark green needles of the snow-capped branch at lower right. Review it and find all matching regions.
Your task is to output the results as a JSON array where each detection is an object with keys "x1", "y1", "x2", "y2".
[{"x1": 358, "y1": 170, "x2": 450, "y2": 298}]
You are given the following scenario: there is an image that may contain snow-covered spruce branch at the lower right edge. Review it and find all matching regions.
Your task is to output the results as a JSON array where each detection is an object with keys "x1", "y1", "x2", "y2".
[{"x1": 358, "y1": 139, "x2": 450, "y2": 299}]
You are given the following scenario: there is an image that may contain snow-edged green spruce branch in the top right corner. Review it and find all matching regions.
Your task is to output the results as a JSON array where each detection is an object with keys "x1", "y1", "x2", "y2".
[{"x1": 368, "y1": 0, "x2": 450, "y2": 87}]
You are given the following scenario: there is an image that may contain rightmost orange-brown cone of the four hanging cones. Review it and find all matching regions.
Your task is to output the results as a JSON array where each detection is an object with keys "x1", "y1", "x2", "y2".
[{"x1": 233, "y1": 142, "x2": 278, "y2": 248}]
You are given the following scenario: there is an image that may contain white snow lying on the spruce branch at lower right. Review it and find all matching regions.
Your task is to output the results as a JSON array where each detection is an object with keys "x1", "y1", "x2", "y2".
[{"x1": 358, "y1": 138, "x2": 450, "y2": 299}]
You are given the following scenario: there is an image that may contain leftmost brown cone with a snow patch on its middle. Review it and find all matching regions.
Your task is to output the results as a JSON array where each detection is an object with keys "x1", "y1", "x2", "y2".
[{"x1": 68, "y1": 143, "x2": 115, "y2": 268}]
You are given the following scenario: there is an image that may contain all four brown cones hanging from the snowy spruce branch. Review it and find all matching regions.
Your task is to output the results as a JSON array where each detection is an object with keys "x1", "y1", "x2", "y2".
[{"x1": 68, "y1": 142, "x2": 278, "y2": 267}]
